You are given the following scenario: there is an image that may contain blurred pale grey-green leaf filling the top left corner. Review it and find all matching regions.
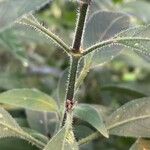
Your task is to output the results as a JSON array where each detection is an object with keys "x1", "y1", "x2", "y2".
[{"x1": 0, "y1": 0, "x2": 50, "y2": 30}]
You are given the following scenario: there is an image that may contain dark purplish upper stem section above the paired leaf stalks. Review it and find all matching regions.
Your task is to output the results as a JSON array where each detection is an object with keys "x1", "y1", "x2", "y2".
[{"x1": 73, "y1": 3, "x2": 89, "y2": 53}]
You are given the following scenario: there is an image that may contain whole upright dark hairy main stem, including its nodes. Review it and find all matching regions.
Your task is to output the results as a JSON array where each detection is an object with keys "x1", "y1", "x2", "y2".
[{"x1": 62, "y1": 2, "x2": 89, "y2": 125}]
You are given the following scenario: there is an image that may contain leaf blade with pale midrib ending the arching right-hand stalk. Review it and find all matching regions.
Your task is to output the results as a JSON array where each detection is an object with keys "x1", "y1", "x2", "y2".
[{"x1": 113, "y1": 25, "x2": 150, "y2": 60}]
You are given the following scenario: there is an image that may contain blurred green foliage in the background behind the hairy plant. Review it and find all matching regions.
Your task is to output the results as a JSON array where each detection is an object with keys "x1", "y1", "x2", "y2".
[{"x1": 0, "y1": 0, "x2": 150, "y2": 150}]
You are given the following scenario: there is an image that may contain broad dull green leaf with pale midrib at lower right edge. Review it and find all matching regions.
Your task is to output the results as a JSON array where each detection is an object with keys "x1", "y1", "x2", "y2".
[{"x1": 106, "y1": 97, "x2": 150, "y2": 137}]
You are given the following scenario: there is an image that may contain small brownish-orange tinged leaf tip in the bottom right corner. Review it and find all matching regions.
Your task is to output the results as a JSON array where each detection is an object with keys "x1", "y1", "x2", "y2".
[{"x1": 130, "y1": 138, "x2": 150, "y2": 150}]
